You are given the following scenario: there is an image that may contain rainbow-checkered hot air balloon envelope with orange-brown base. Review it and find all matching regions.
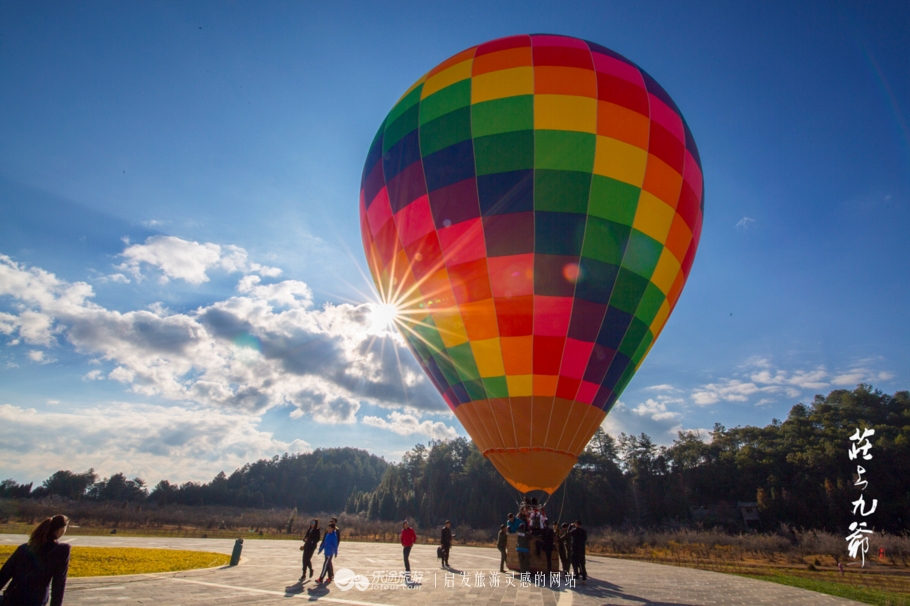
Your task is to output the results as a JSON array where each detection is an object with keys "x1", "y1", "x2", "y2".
[{"x1": 360, "y1": 35, "x2": 703, "y2": 494}]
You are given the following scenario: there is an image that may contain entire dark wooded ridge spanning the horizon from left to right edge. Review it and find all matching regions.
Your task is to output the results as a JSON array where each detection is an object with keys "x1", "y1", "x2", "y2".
[{"x1": 0, "y1": 385, "x2": 910, "y2": 533}]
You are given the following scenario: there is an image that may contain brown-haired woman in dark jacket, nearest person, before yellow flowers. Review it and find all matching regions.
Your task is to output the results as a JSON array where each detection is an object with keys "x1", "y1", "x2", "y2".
[{"x1": 0, "y1": 515, "x2": 70, "y2": 606}]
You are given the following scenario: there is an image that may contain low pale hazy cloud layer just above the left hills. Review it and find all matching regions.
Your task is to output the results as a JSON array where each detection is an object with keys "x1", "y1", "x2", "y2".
[{"x1": 0, "y1": 402, "x2": 310, "y2": 484}]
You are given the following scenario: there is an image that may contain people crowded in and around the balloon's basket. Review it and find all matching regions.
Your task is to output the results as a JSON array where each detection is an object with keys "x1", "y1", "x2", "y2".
[{"x1": 496, "y1": 498, "x2": 588, "y2": 583}]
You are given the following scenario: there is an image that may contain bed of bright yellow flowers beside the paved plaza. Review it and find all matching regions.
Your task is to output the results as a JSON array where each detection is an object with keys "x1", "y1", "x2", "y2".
[{"x1": 0, "y1": 545, "x2": 231, "y2": 577}]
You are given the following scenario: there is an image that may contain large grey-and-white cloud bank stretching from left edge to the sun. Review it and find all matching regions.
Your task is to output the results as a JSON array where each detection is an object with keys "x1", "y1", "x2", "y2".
[{"x1": 0, "y1": 255, "x2": 445, "y2": 423}]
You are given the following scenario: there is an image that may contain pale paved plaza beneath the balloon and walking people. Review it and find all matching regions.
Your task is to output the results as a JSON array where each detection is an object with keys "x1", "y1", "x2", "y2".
[{"x1": 0, "y1": 535, "x2": 858, "y2": 606}]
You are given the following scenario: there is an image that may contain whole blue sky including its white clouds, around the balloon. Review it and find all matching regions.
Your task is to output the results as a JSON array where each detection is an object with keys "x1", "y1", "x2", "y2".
[{"x1": 0, "y1": 2, "x2": 910, "y2": 482}]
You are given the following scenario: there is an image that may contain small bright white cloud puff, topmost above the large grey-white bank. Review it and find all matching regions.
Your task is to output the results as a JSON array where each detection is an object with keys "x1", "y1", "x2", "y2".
[{"x1": 115, "y1": 236, "x2": 281, "y2": 284}]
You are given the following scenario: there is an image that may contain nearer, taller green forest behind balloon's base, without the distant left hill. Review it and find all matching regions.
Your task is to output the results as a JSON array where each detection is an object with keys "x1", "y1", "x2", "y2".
[{"x1": 346, "y1": 385, "x2": 910, "y2": 533}]
